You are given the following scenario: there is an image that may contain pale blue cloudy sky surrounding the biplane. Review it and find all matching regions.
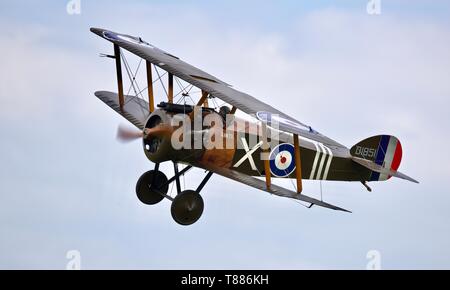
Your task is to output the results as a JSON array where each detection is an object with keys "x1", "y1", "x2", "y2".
[{"x1": 0, "y1": 0, "x2": 450, "y2": 269}]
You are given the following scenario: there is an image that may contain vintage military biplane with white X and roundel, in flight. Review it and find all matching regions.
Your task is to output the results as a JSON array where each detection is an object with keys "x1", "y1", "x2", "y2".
[{"x1": 91, "y1": 28, "x2": 418, "y2": 225}]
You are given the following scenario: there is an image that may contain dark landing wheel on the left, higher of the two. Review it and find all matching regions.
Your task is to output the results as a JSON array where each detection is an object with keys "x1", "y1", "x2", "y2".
[{"x1": 136, "y1": 170, "x2": 169, "y2": 205}]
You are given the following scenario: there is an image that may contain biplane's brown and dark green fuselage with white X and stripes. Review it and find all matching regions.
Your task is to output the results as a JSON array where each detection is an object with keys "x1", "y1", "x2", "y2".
[{"x1": 144, "y1": 110, "x2": 371, "y2": 181}]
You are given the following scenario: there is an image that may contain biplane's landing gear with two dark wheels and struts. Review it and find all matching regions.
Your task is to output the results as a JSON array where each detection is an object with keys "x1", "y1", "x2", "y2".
[{"x1": 136, "y1": 163, "x2": 212, "y2": 226}]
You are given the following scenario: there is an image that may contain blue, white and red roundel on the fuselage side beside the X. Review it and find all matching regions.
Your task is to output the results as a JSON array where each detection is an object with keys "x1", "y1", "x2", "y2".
[{"x1": 270, "y1": 143, "x2": 295, "y2": 177}]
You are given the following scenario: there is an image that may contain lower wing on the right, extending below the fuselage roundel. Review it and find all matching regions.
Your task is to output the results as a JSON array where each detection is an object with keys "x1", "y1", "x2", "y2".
[{"x1": 203, "y1": 165, "x2": 351, "y2": 213}]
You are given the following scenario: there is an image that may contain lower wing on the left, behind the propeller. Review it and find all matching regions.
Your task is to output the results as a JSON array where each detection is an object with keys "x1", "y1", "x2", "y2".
[{"x1": 95, "y1": 91, "x2": 150, "y2": 130}]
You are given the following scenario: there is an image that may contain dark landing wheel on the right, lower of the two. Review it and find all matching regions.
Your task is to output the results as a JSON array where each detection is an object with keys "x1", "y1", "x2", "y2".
[{"x1": 170, "y1": 190, "x2": 204, "y2": 226}]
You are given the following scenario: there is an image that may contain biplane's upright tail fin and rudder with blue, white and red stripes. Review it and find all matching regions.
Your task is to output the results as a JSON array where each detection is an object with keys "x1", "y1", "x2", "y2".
[{"x1": 350, "y1": 135, "x2": 402, "y2": 181}]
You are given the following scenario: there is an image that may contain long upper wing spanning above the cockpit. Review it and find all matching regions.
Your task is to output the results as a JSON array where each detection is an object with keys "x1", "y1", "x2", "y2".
[{"x1": 91, "y1": 28, "x2": 344, "y2": 147}]
